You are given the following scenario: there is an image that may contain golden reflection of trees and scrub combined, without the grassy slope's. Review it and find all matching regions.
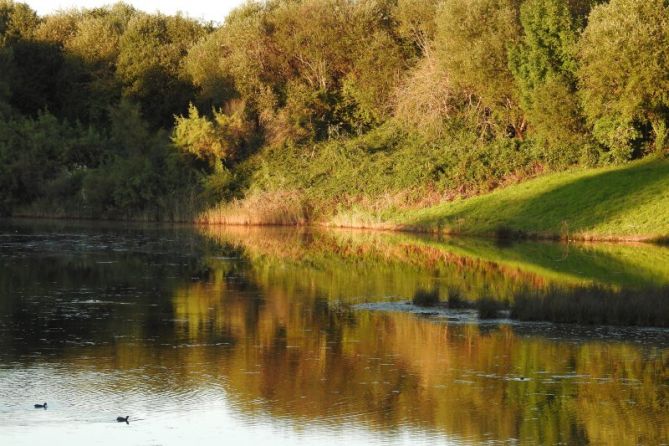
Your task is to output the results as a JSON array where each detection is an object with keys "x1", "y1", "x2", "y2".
[{"x1": 166, "y1": 230, "x2": 669, "y2": 444}]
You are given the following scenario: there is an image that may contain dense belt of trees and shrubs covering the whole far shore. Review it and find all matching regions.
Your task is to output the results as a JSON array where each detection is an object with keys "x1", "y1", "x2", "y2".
[{"x1": 0, "y1": 0, "x2": 669, "y2": 220}]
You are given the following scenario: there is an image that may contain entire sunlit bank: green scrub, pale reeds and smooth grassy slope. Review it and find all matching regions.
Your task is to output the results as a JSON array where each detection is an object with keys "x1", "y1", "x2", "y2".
[{"x1": 195, "y1": 125, "x2": 669, "y2": 241}]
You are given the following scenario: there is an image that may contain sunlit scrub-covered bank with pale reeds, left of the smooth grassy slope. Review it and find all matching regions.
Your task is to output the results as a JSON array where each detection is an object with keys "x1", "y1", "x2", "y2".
[{"x1": 209, "y1": 122, "x2": 538, "y2": 229}]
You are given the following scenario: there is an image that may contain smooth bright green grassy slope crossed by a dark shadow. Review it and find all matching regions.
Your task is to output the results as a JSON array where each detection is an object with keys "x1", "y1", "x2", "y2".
[{"x1": 390, "y1": 159, "x2": 669, "y2": 240}]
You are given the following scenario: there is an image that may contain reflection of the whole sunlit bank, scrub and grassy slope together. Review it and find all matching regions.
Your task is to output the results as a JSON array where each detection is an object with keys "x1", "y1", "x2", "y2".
[{"x1": 202, "y1": 227, "x2": 669, "y2": 310}]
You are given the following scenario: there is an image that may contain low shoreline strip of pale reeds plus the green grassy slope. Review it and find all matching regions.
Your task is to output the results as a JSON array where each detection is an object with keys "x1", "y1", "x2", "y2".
[{"x1": 7, "y1": 158, "x2": 669, "y2": 243}]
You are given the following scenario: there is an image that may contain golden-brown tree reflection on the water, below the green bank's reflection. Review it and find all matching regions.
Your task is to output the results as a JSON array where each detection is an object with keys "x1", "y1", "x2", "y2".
[{"x1": 168, "y1": 265, "x2": 668, "y2": 444}]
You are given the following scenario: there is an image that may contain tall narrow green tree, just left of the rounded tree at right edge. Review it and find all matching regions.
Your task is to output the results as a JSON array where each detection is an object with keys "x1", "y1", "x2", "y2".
[{"x1": 509, "y1": 0, "x2": 590, "y2": 164}]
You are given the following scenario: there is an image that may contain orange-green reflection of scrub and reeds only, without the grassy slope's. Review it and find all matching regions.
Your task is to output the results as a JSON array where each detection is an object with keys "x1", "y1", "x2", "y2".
[{"x1": 203, "y1": 228, "x2": 536, "y2": 302}]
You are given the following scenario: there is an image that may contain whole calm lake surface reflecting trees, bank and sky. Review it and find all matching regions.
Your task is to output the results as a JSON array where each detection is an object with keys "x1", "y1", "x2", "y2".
[{"x1": 0, "y1": 222, "x2": 669, "y2": 445}]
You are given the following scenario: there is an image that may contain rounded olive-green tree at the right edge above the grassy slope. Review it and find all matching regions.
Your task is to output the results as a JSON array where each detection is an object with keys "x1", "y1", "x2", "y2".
[{"x1": 578, "y1": 0, "x2": 669, "y2": 160}]
